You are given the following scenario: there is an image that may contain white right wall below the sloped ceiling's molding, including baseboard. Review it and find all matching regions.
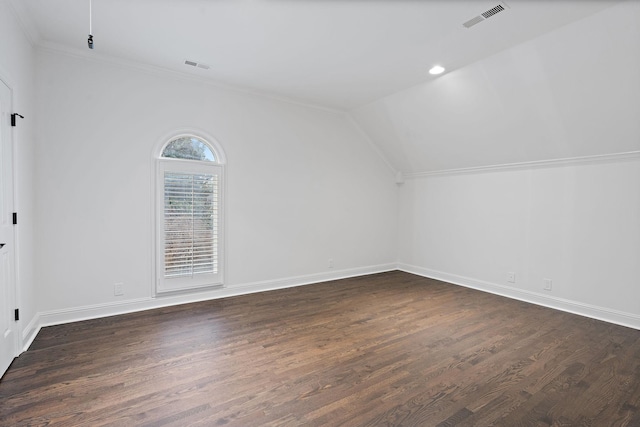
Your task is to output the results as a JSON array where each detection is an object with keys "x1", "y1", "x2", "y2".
[{"x1": 399, "y1": 154, "x2": 640, "y2": 328}]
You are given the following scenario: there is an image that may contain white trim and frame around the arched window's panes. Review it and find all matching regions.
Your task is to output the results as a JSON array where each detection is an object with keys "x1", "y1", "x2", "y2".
[{"x1": 152, "y1": 129, "x2": 226, "y2": 297}]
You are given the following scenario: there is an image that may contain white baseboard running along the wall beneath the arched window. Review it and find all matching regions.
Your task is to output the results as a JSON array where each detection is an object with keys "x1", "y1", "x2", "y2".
[{"x1": 32, "y1": 263, "x2": 397, "y2": 350}]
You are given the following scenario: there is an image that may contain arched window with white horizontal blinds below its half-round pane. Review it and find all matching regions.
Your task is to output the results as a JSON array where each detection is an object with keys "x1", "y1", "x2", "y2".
[{"x1": 156, "y1": 135, "x2": 224, "y2": 293}]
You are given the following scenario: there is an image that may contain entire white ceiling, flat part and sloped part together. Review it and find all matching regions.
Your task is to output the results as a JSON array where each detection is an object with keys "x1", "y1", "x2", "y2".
[{"x1": 11, "y1": 0, "x2": 640, "y2": 174}]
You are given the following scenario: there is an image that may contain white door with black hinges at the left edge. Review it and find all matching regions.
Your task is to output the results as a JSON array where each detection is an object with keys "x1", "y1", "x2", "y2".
[{"x1": 0, "y1": 80, "x2": 18, "y2": 377}]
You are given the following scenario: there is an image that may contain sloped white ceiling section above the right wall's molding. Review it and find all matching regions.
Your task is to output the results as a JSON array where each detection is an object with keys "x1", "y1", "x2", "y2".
[{"x1": 352, "y1": 2, "x2": 640, "y2": 175}]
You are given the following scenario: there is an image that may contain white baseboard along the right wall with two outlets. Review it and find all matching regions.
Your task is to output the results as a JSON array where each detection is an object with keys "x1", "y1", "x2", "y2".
[{"x1": 398, "y1": 263, "x2": 640, "y2": 329}]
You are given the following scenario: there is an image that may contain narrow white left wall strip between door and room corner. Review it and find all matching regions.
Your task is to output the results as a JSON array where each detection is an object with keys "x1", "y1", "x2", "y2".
[{"x1": 0, "y1": 0, "x2": 37, "y2": 352}]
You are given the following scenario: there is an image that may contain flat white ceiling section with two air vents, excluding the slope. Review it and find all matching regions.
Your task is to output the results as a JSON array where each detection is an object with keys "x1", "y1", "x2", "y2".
[{"x1": 12, "y1": 0, "x2": 619, "y2": 110}]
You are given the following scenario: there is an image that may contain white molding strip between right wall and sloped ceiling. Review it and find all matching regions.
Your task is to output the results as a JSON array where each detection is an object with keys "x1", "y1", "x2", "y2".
[{"x1": 403, "y1": 151, "x2": 640, "y2": 179}]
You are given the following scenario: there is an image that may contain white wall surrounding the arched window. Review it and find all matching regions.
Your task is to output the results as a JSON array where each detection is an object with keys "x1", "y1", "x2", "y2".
[{"x1": 37, "y1": 51, "x2": 397, "y2": 324}]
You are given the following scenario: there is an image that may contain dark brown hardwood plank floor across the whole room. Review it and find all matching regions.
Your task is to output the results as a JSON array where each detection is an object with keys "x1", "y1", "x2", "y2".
[{"x1": 0, "y1": 272, "x2": 640, "y2": 426}]
